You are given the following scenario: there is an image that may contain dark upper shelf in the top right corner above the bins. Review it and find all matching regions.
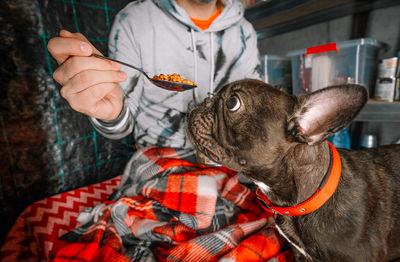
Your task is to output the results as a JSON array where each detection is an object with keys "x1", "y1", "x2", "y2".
[{"x1": 245, "y1": 0, "x2": 400, "y2": 39}]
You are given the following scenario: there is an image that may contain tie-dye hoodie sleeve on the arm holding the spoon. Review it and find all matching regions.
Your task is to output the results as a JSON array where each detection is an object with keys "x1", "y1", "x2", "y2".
[{"x1": 90, "y1": 9, "x2": 142, "y2": 139}]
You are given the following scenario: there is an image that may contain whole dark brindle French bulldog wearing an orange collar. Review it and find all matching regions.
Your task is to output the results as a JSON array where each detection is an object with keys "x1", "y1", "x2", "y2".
[{"x1": 187, "y1": 79, "x2": 400, "y2": 262}]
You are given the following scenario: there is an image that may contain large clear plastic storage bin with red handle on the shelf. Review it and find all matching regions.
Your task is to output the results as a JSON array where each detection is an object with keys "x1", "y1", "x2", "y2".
[{"x1": 287, "y1": 38, "x2": 384, "y2": 94}]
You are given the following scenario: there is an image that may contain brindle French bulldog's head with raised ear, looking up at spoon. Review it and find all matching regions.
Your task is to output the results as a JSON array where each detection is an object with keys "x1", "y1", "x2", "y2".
[{"x1": 187, "y1": 79, "x2": 368, "y2": 175}]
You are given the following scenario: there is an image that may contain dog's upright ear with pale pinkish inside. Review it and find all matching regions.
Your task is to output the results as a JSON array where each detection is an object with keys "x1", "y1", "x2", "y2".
[{"x1": 287, "y1": 85, "x2": 368, "y2": 145}]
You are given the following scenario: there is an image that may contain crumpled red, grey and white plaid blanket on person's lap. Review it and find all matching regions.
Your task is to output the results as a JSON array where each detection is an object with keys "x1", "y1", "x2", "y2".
[{"x1": 51, "y1": 147, "x2": 293, "y2": 262}]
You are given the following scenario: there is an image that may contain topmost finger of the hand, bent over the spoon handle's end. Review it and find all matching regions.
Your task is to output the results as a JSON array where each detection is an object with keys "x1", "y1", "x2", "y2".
[{"x1": 47, "y1": 37, "x2": 94, "y2": 64}]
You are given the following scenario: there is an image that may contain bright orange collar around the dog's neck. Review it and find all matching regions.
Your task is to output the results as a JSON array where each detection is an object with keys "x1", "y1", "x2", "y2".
[{"x1": 257, "y1": 142, "x2": 342, "y2": 216}]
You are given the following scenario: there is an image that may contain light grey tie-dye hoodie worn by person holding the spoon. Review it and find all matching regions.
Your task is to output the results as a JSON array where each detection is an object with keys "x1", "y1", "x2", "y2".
[{"x1": 91, "y1": 0, "x2": 261, "y2": 148}]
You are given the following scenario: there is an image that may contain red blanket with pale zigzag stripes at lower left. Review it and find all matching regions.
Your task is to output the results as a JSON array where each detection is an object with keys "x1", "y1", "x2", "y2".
[{"x1": 0, "y1": 176, "x2": 122, "y2": 262}]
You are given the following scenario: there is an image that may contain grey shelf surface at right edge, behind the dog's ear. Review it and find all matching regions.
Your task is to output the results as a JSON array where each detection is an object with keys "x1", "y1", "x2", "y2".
[{"x1": 354, "y1": 100, "x2": 400, "y2": 122}]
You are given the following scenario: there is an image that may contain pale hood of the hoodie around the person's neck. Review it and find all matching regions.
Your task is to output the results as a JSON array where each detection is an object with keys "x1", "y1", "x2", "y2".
[{"x1": 153, "y1": 0, "x2": 244, "y2": 32}]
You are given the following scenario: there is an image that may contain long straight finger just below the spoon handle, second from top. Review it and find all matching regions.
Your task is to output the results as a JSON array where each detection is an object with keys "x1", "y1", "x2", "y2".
[{"x1": 53, "y1": 56, "x2": 121, "y2": 85}]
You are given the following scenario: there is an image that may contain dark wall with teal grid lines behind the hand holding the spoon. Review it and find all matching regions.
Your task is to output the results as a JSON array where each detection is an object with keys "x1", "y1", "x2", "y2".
[{"x1": 0, "y1": 0, "x2": 133, "y2": 246}]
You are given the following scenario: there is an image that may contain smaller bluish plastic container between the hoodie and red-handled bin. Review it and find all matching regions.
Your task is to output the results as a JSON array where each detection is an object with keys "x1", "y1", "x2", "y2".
[{"x1": 261, "y1": 55, "x2": 292, "y2": 93}]
